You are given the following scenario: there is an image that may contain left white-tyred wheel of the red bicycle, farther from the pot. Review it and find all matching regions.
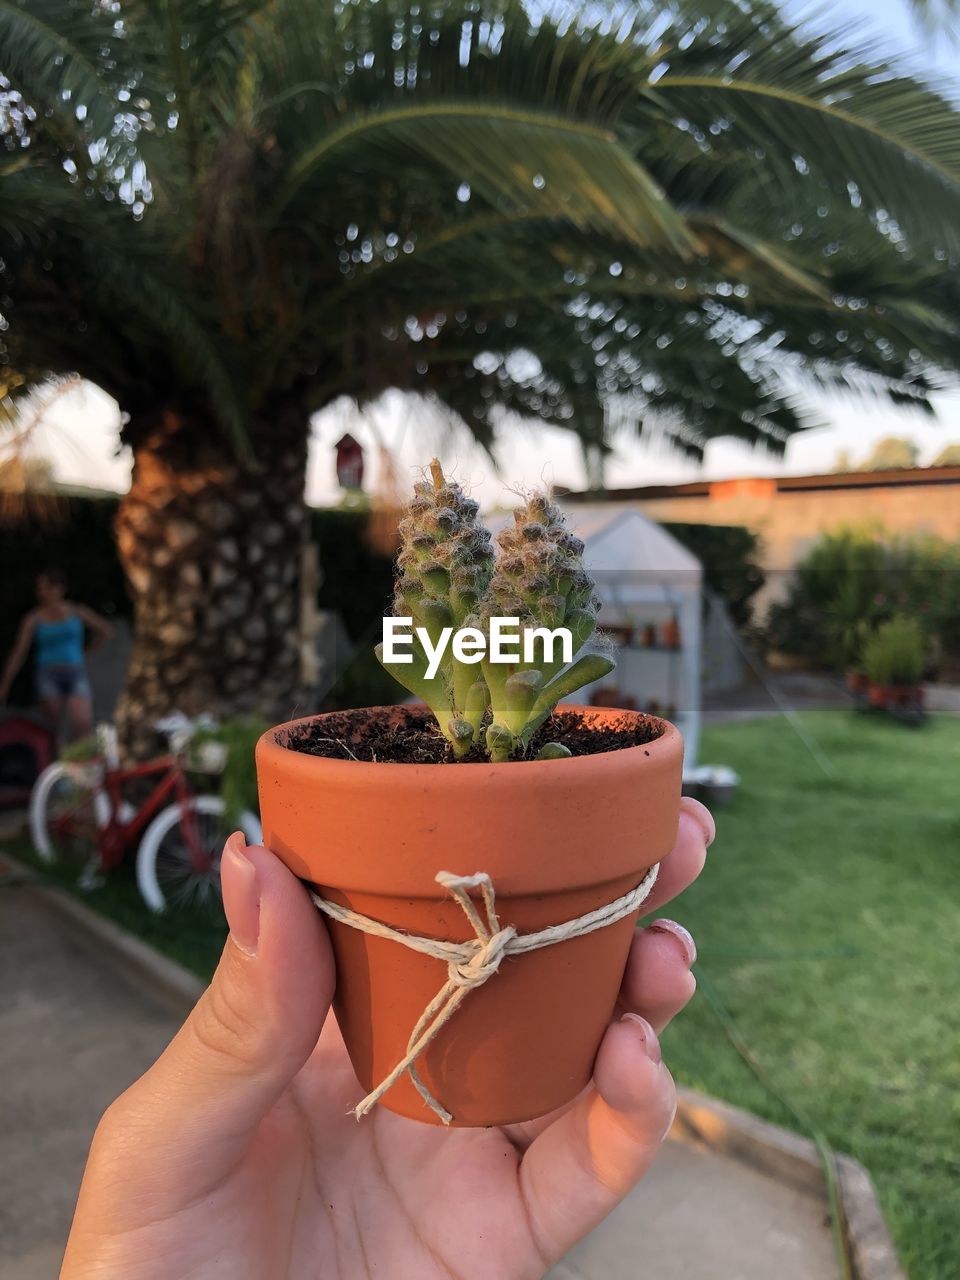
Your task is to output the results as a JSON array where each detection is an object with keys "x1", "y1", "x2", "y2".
[{"x1": 29, "y1": 764, "x2": 110, "y2": 883}]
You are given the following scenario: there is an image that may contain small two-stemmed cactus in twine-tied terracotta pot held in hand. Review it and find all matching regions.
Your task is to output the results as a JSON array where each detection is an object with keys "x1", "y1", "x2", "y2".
[{"x1": 256, "y1": 462, "x2": 682, "y2": 1125}]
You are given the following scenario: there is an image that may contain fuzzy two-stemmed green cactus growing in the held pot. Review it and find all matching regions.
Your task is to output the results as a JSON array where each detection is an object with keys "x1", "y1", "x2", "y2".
[{"x1": 376, "y1": 460, "x2": 613, "y2": 762}]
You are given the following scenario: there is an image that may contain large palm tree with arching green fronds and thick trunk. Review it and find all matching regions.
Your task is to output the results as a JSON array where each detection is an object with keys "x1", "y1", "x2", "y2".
[{"x1": 0, "y1": 0, "x2": 960, "y2": 742}]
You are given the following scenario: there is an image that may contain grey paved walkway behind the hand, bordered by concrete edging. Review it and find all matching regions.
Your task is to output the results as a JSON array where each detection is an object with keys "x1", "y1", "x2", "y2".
[{"x1": 0, "y1": 860, "x2": 836, "y2": 1280}]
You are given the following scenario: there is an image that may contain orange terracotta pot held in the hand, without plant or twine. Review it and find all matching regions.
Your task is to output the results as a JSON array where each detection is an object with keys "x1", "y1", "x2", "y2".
[{"x1": 256, "y1": 708, "x2": 684, "y2": 1125}]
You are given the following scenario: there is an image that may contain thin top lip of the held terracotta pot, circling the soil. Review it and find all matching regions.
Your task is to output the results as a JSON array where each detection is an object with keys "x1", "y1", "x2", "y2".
[{"x1": 256, "y1": 703, "x2": 682, "y2": 787}]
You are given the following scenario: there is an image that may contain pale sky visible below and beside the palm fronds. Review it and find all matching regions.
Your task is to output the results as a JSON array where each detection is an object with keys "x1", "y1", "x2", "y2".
[{"x1": 22, "y1": 0, "x2": 960, "y2": 506}]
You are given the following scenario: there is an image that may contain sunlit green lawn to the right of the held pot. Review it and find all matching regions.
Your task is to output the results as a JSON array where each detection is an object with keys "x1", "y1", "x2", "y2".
[{"x1": 664, "y1": 712, "x2": 960, "y2": 1280}]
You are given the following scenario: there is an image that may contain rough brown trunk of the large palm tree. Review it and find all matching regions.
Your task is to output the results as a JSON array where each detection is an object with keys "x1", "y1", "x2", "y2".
[{"x1": 116, "y1": 407, "x2": 307, "y2": 758}]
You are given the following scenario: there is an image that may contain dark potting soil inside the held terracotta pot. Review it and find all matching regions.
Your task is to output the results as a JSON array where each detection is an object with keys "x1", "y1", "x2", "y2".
[{"x1": 284, "y1": 709, "x2": 663, "y2": 764}]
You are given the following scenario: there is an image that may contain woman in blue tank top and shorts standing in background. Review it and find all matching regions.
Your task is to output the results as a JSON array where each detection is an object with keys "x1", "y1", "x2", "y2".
[{"x1": 0, "y1": 568, "x2": 113, "y2": 739}]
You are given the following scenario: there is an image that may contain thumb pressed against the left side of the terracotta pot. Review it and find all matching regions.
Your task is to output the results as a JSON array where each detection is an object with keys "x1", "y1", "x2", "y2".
[{"x1": 111, "y1": 833, "x2": 334, "y2": 1179}]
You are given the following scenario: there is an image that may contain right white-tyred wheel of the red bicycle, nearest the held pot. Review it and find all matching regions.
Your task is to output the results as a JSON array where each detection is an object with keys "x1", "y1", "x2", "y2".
[{"x1": 137, "y1": 796, "x2": 262, "y2": 911}]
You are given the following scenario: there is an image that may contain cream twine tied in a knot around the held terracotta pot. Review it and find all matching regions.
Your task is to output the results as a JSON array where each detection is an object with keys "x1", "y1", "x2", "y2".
[{"x1": 311, "y1": 863, "x2": 659, "y2": 1124}]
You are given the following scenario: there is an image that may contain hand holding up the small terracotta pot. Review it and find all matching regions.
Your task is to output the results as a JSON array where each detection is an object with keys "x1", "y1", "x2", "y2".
[{"x1": 61, "y1": 800, "x2": 714, "y2": 1280}]
